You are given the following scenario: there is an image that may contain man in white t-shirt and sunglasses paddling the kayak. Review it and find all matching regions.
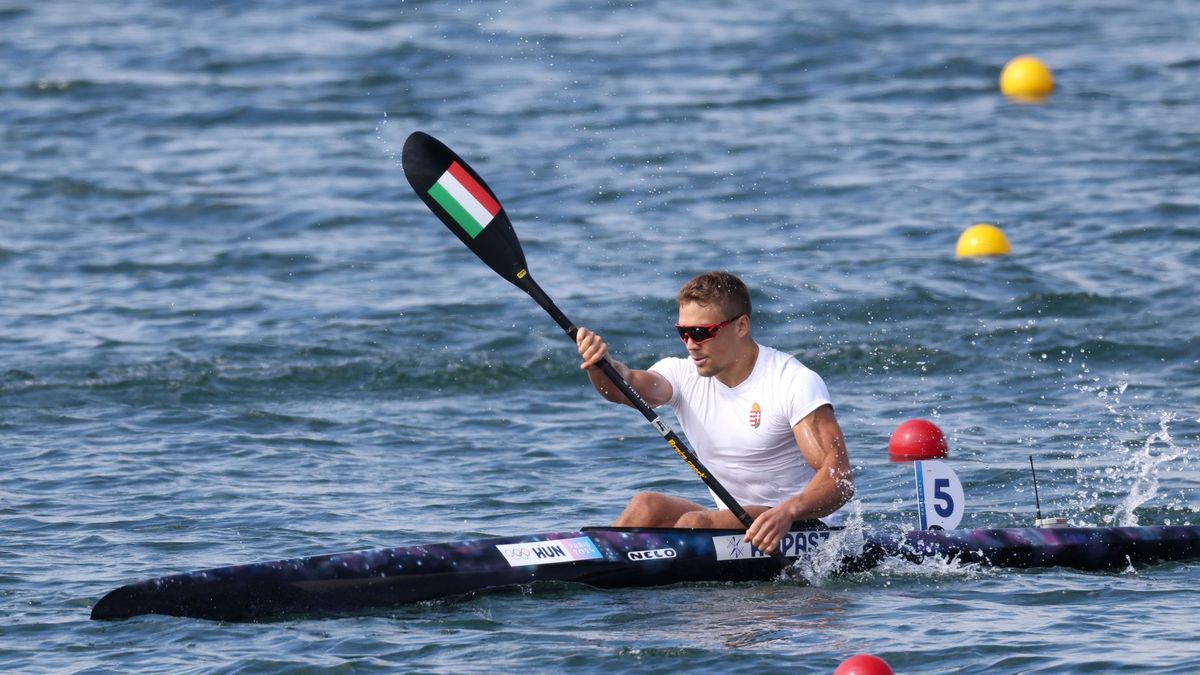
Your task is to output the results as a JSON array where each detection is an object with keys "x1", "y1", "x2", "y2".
[{"x1": 576, "y1": 271, "x2": 854, "y2": 554}]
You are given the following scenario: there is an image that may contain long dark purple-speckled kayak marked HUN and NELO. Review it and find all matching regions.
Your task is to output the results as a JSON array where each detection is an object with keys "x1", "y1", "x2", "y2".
[{"x1": 91, "y1": 525, "x2": 1200, "y2": 621}]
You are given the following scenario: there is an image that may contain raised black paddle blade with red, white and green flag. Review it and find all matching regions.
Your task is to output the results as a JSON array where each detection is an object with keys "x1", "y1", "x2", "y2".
[{"x1": 401, "y1": 131, "x2": 528, "y2": 285}]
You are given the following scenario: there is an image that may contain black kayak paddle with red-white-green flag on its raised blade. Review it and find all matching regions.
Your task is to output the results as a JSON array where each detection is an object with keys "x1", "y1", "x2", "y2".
[{"x1": 402, "y1": 131, "x2": 788, "y2": 569}]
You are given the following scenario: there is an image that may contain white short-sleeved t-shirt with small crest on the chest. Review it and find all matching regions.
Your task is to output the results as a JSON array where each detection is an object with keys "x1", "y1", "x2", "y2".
[{"x1": 650, "y1": 345, "x2": 830, "y2": 508}]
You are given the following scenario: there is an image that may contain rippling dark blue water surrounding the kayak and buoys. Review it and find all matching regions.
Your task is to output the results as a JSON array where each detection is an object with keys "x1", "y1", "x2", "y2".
[{"x1": 0, "y1": 0, "x2": 1200, "y2": 674}]
